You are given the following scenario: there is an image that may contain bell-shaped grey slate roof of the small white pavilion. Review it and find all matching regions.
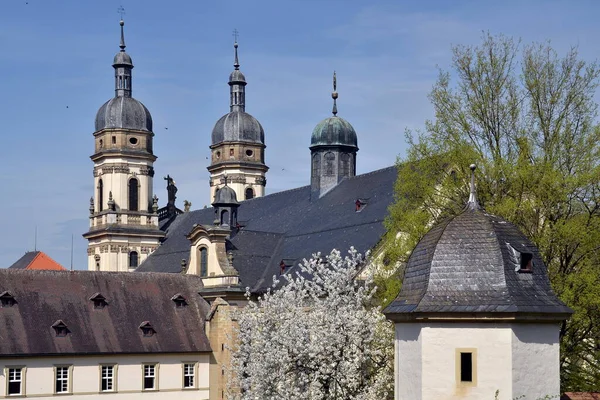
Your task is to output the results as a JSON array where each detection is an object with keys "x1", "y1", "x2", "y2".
[{"x1": 384, "y1": 207, "x2": 572, "y2": 319}]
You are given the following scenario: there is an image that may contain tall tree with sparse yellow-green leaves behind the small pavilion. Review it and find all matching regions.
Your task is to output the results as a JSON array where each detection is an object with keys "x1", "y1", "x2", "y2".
[{"x1": 377, "y1": 34, "x2": 600, "y2": 391}]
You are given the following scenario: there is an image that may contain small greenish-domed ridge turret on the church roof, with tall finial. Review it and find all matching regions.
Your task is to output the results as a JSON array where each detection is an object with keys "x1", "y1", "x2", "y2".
[{"x1": 310, "y1": 72, "x2": 358, "y2": 199}]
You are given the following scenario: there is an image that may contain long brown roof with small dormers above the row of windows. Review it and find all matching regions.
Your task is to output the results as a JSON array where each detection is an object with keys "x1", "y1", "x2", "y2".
[{"x1": 0, "y1": 269, "x2": 210, "y2": 357}]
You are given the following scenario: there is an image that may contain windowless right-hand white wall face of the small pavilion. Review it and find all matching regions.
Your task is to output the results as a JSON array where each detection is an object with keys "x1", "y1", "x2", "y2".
[{"x1": 512, "y1": 324, "x2": 560, "y2": 399}]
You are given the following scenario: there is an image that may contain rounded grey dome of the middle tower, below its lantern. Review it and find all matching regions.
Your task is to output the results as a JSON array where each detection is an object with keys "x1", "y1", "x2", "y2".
[{"x1": 212, "y1": 111, "x2": 265, "y2": 145}]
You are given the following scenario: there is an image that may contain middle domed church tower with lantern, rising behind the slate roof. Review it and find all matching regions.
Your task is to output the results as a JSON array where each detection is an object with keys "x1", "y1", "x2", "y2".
[{"x1": 207, "y1": 40, "x2": 269, "y2": 203}]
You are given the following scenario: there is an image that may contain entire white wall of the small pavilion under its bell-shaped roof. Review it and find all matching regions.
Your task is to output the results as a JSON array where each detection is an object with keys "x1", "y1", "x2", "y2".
[{"x1": 395, "y1": 322, "x2": 560, "y2": 400}]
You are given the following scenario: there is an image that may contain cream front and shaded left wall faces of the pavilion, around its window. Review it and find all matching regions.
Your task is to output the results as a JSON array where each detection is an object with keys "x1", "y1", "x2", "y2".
[{"x1": 396, "y1": 322, "x2": 512, "y2": 400}]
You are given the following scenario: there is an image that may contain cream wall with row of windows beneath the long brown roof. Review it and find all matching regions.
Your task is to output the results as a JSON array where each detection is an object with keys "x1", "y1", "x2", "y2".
[{"x1": 0, "y1": 353, "x2": 210, "y2": 400}]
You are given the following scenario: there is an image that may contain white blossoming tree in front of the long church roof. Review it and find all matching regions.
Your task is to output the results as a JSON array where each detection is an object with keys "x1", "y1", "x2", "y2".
[{"x1": 229, "y1": 249, "x2": 393, "y2": 400}]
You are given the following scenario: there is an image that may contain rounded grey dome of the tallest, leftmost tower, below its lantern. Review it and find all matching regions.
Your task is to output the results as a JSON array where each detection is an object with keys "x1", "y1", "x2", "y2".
[{"x1": 96, "y1": 97, "x2": 152, "y2": 132}]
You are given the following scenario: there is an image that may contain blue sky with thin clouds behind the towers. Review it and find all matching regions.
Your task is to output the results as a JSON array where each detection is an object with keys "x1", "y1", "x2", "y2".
[{"x1": 0, "y1": 0, "x2": 600, "y2": 269}]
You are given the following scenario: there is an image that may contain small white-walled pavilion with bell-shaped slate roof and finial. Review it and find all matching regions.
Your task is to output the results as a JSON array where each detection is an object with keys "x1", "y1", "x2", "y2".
[{"x1": 384, "y1": 165, "x2": 572, "y2": 400}]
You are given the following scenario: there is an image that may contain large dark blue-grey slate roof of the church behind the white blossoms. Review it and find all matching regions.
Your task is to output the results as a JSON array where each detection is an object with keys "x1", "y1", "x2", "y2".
[{"x1": 136, "y1": 167, "x2": 397, "y2": 292}]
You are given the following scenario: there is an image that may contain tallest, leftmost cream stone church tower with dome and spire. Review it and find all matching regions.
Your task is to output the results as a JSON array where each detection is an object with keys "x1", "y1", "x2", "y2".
[{"x1": 83, "y1": 20, "x2": 164, "y2": 271}]
